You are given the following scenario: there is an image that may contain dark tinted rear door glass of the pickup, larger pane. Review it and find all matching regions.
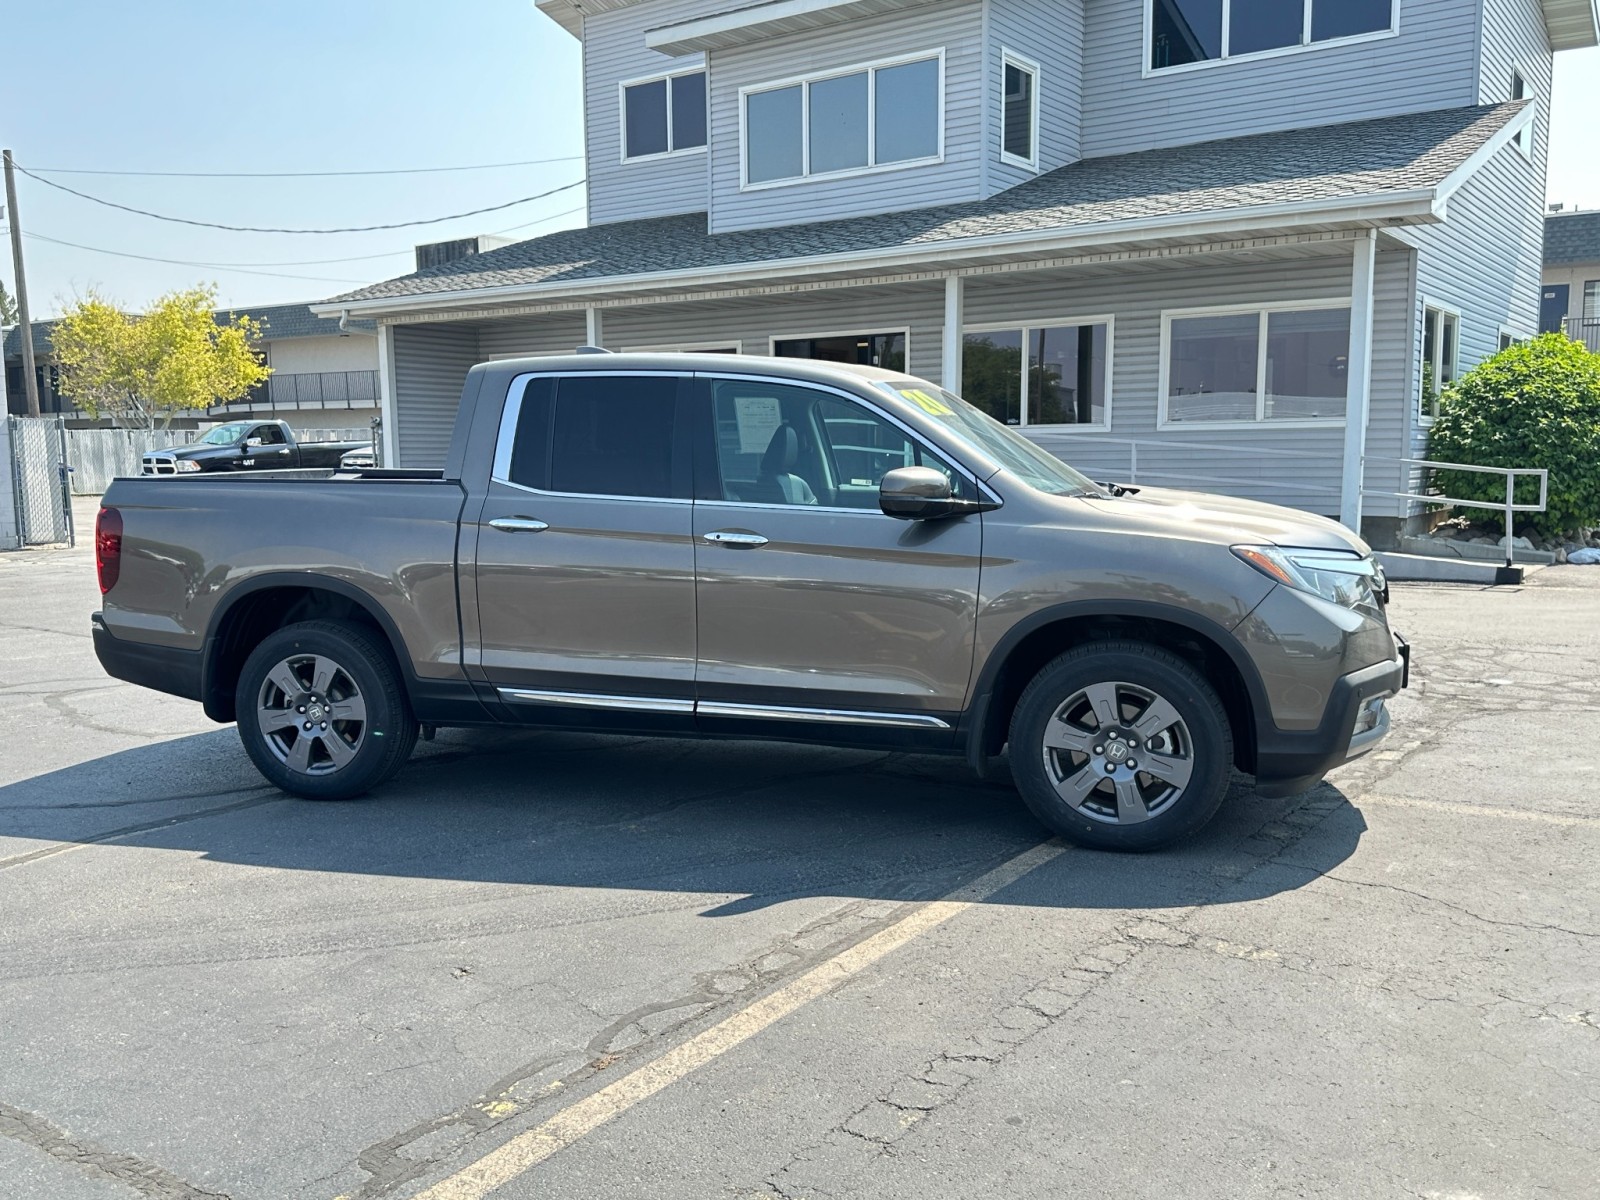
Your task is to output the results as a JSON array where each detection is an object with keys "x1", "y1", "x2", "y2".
[{"x1": 550, "y1": 374, "x2": 678, "y2": 496}]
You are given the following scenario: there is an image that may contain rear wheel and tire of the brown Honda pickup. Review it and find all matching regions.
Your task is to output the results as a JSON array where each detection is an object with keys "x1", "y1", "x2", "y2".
[{"x1": 234, "y1": 621, "x2": 418, "y2": 800}]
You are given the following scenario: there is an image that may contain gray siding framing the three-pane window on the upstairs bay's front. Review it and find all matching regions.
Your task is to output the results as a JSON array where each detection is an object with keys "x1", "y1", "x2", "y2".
[{"x1": 710, "y1": 0, "x2": 984, "y2": 232}]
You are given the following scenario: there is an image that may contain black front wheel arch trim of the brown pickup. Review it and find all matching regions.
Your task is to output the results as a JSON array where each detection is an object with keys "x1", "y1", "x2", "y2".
[{"x1": 965, "y1": 600, "x2": 1272, "y2": 773}]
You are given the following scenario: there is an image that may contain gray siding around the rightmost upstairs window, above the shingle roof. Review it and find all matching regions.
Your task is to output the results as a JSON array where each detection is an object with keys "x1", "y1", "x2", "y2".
[{"x1": 1083, "y1": 0, "x2": 1478, "y2": 157}]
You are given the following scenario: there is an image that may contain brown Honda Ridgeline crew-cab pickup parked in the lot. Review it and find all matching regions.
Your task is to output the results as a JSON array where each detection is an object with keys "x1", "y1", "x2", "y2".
[{"x1": 93, "y1": 352, "x2": 1408, "y2": 850}]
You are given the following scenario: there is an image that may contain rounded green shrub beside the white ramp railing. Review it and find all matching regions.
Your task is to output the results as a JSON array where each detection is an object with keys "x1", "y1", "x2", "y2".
[{"x1": 1427, "y1": 333, "x2": 1600, "y2": 538}]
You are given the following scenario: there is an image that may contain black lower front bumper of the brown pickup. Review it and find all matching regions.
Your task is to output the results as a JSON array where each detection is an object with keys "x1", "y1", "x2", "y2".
[{"x1": 1256, "y1": 635, "x2": 1411, "y2": 798}]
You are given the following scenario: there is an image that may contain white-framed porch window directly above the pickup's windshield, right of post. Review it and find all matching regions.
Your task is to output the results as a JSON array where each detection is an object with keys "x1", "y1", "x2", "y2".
[{"x1": 962, "y1": 317, "x2": 1110, "y2": 429}]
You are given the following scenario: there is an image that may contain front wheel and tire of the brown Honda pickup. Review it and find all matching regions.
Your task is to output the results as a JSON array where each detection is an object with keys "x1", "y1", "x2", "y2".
[{"x1": 1010, "y1": 642, "x2": 1234, "y2": 851}]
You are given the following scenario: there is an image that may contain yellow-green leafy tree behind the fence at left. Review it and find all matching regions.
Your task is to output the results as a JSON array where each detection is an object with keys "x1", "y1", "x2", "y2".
[{"x1": 51, "y1": 286, "x2": 270, "y2": 429}]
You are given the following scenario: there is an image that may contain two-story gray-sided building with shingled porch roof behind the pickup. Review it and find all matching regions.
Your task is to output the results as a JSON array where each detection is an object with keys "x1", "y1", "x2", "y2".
[{"x1": 305, "y1": 0, "x2": 1600, "y2": 536}]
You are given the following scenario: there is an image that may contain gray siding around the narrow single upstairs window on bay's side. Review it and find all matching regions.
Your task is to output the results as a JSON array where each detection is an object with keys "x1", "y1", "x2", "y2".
[{"x1": 984, "y1": 0, "x2": 1083, "y2": 195}]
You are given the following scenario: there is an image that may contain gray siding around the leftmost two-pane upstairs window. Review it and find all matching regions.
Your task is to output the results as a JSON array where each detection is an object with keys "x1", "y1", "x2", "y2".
[{"x1": 584, "y1": 0, "x2": 726, "y2": 226}]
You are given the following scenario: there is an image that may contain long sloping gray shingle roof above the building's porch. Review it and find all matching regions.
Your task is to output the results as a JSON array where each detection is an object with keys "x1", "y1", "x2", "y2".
[{"x1": 325, "y1": 102, "x2": 1523, "y2": 304}]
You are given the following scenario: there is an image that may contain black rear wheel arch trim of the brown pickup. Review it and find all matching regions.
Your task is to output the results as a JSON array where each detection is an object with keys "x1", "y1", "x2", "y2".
[{"x1": 200, "y1": 571, "x2": 416, "y2": 722}]
